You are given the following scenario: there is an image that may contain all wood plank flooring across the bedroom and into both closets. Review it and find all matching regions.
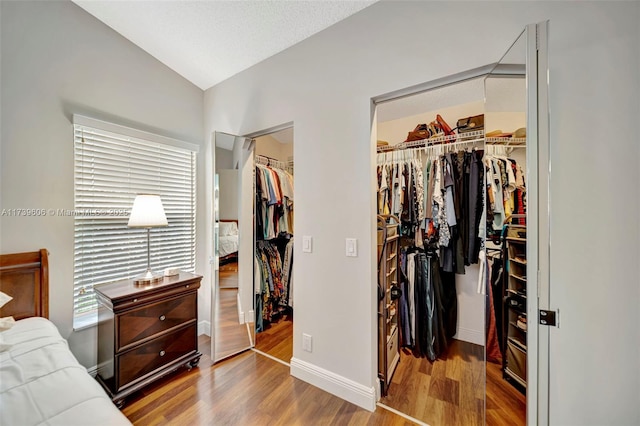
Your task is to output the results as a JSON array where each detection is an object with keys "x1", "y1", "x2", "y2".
[{"x1": 150, "y1": 266, "x2": 526, "y2": 426}]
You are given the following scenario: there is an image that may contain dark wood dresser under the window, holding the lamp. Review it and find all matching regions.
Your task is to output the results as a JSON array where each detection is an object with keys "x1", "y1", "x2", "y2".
[{"x1": 94, "y1": 272, "x2": 202, "y2": 407}]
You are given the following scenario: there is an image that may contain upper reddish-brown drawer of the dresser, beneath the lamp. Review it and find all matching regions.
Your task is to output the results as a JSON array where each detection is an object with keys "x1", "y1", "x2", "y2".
[{"x1": 116, "y1": 292, "x2": 198, "y2": 351}]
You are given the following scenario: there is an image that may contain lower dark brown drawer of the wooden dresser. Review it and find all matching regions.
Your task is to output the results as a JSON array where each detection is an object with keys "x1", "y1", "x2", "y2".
[{"x1": 116, "y1": 323, "x2": 197, "y2": 390}]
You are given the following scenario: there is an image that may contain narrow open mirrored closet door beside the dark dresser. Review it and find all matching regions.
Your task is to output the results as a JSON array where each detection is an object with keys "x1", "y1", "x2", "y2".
[{"x1": 211, "y1": 132, "x2": 255, "y2": 362}]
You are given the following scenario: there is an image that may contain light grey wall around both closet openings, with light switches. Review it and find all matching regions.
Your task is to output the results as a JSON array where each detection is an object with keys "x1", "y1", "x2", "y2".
[{"x1": 205, "y1": 1, "x2": 640, "y2": 424}]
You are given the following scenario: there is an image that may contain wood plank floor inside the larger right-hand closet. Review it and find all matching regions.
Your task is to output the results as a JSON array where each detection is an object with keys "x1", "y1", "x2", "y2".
[{"x1": 380, "y1": 340, "x2": 526, "y2": 426}]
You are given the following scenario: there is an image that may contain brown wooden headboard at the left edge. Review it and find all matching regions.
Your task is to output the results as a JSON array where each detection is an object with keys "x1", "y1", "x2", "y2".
[{"x1": 0, "y1": 249, "x2": 49, "y2": 321}]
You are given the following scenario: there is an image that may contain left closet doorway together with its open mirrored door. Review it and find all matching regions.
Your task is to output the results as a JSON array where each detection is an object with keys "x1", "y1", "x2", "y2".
[{"x1": 211, "y1": 125, "x2": 294, "y2": 363}]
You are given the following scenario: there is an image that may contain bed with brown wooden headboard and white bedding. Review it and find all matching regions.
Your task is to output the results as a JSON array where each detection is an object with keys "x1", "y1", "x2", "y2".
[{"x1": 0, "y1": 249, "x2": 131, "y2": 426}]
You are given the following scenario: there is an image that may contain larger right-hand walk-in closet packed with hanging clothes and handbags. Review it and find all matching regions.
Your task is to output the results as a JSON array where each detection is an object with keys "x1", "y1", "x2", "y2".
[{"x1": 374, "y1": 29, "x2": 527, "y2": 425}]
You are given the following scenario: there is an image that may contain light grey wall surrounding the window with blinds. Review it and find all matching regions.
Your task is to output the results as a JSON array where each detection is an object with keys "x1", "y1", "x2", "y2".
[{"x1": 0, "y1": 1, "x2": 209, "y2": 367}]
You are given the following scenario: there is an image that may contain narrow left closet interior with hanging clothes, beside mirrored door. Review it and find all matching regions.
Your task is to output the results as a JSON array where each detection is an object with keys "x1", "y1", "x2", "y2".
[{"x1": 254, "y1": 127, "x2": 295, "y2": 363}]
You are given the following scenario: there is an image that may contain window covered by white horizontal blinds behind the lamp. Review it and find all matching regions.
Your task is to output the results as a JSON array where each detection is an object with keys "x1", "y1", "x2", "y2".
[{"x1": 73, "y1": 116, "x2": 197, "y2": 329}]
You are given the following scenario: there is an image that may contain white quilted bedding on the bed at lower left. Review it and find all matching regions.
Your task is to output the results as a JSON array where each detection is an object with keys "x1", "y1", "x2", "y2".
[{"x1": 0, "y1": 318, "x2": 131, "y2": 426}]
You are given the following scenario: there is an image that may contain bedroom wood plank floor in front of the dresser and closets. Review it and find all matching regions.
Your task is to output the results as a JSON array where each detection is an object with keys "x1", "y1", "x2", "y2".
[{"x1": 122, "y1": 336, "x2": 413, "y2": 426}]
